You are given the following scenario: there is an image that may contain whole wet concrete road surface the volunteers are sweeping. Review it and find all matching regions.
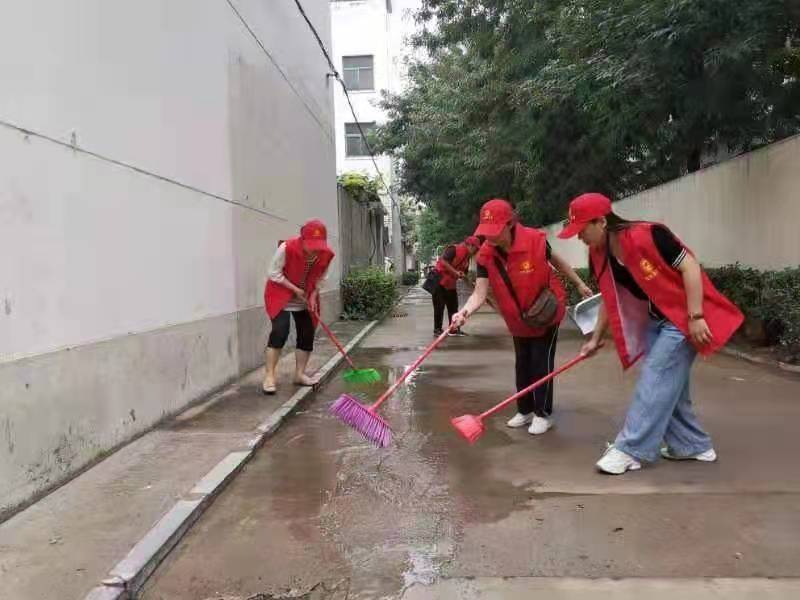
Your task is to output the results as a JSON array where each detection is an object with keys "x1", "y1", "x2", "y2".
[{"x1": 143, "y1": 290, "x2": 800, "y2": 600}]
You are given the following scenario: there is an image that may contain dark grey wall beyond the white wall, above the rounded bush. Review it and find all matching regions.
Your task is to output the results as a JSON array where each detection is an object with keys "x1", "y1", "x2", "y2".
[{"x1": 338, "y1": 187, "x2": 386, "y2": 275}]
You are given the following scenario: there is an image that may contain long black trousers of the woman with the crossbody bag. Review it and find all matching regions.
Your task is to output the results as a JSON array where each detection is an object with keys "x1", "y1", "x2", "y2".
[{"x1": 514, "y1": 327, "x2": 558, "y2": 417}]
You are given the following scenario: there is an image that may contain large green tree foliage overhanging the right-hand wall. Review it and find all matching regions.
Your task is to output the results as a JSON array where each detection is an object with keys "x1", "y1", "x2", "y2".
[{"x1": 376, "y1": 0, "x2": 800, "y2": 234}]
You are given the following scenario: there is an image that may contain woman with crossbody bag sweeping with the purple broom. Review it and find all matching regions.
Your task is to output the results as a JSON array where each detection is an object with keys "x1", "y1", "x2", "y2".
[{"x1": 453, "y1": 199, "x2": 592, "y2": 435}]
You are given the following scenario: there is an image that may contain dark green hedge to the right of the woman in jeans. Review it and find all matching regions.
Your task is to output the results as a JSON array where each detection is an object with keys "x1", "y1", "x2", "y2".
[{"x1": 706, "y1": 263, "x2": 800, "y2": 360}]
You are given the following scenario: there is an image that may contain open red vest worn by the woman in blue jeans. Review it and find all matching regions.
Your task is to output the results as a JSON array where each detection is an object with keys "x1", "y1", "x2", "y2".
[{"x1": 590, "y1": 223, "x2": 744, "y2": 369}]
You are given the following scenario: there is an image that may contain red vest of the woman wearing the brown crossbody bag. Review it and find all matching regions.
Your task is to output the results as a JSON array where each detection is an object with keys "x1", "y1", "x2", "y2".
[{"x1": 478, "y1": 225, "x2": 567, "y2": 337}]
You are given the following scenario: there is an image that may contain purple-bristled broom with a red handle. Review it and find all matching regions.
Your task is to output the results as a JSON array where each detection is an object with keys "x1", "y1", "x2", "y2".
[{"x1": 331, "y1": 325, "x2": 453, "y2": 448}]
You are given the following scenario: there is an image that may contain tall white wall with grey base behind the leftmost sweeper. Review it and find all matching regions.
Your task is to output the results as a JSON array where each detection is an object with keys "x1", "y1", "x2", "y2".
[{"x1": 0, "y1": 0, "x2": 340, "y2": 512}]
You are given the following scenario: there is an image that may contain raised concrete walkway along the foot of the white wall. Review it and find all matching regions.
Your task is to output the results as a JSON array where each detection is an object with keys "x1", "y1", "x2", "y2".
[{"x1": 0, "y1": 322, "x2": 366, "y2": 600}]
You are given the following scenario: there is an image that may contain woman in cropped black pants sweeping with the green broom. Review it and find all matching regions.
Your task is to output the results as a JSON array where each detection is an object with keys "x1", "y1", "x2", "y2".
[{"x1": 262, "y1": 219, "x2": 334, "y2": 394}]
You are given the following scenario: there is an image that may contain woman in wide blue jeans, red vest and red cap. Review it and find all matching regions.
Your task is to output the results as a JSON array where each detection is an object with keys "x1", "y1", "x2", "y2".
[{"x1": 559, "y1": 194, "x2": 743, "y2": 475}]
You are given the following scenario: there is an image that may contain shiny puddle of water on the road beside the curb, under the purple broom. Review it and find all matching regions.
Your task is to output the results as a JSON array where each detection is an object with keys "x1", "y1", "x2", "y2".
[{"x1": 145, "y1": 338, "x2": 530, "y2": 600}]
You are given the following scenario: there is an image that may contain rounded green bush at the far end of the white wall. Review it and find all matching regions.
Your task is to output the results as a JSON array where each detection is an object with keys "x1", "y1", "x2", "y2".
[{"x1": 342, "y1": 267, "x2": 397, "y2": 321}]
